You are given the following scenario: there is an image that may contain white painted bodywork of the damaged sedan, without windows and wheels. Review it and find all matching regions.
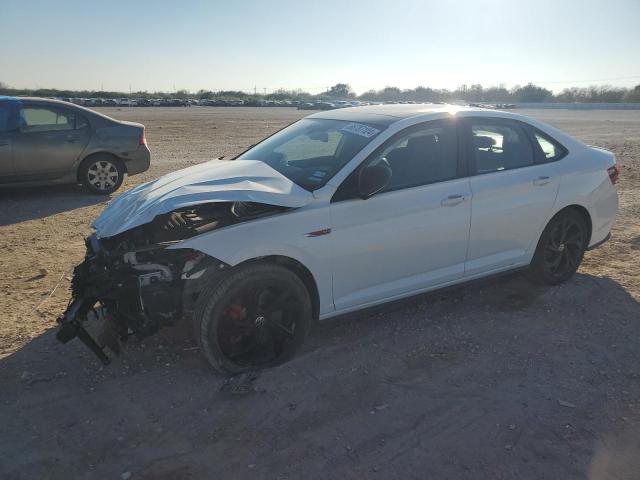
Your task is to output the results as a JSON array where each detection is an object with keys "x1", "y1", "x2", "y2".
[{"x1": 95, "y1": 105, "x2": 617, "y2": 319}]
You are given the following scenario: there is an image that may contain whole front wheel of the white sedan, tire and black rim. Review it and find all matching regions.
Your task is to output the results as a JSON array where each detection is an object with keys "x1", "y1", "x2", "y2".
[{"x1": 193, "y1": 263, "x2": 312, "y2": 375}]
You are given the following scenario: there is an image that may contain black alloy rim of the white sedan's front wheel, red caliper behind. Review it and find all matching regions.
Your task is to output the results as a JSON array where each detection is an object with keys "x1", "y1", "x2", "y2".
[{"x1": 216, "y1": 286, "x2": 302, "y2": 367}]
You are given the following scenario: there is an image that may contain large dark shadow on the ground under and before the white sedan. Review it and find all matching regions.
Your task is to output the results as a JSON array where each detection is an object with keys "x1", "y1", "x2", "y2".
[{"x1": 0, "y1": 274, "x2": 640, "y2": 479}]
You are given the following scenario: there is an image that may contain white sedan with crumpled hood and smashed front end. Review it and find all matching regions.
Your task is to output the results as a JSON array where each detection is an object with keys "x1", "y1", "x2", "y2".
[{"x1": 58, "y1": 105, "x2": 619, "y2": 374}]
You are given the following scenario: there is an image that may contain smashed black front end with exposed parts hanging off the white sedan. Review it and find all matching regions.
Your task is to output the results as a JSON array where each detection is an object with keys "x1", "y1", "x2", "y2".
[{"x1": 56, "y1": 235, "x2": 191, "y2": 365}]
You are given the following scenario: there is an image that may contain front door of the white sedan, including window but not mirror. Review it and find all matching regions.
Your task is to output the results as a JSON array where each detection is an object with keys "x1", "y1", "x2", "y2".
[{"x1": 330, "y1": 121, "x2": 471, "y2": 311}]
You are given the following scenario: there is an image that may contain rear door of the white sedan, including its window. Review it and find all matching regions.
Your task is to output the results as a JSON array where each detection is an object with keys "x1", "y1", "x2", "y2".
[{"x1": 461, "y1": 117, "x2": 559, "y2": 276}]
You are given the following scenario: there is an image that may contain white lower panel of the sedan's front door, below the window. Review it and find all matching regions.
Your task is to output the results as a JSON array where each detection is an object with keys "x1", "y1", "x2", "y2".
[{"x1": 330, "y1": 178, "x2": 471, "y2": 310}]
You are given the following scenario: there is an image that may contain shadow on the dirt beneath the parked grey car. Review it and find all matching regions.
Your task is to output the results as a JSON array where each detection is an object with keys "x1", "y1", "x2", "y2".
[{"x1": 0, "y1": 185, "x2": 111, "y2": 226}]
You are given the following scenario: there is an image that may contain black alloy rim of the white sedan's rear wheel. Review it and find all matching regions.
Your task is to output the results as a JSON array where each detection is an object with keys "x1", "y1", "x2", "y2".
[{"x1": 544, "y1": 218, "x2": 584, "y2": 277}]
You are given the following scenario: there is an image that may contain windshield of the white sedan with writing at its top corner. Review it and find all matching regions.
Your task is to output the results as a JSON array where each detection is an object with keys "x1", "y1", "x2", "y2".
[{"x1": 237, "y1": 118, "x2": 385, "y2": 191}]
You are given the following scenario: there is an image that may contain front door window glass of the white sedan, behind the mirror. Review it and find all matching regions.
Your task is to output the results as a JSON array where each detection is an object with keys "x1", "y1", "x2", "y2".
[{"x1": 370, "y1": 122, "x2": 458, "y2": 192}]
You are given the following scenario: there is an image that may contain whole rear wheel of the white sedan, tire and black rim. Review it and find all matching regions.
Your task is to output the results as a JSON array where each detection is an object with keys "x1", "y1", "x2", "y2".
[{"x1": 528, "y1": 210, "x2": 589, "y2": 285}]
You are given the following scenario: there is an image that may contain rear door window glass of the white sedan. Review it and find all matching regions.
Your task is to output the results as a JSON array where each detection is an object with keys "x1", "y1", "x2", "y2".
[{"x1": 470, "y1": 119, "x2": 534, "y2": 173}]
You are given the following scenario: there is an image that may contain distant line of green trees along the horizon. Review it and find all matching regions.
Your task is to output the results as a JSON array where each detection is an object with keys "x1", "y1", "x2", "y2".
[{"x1": 0, "y1": 82, "x2": 640, "y2": 103}]
